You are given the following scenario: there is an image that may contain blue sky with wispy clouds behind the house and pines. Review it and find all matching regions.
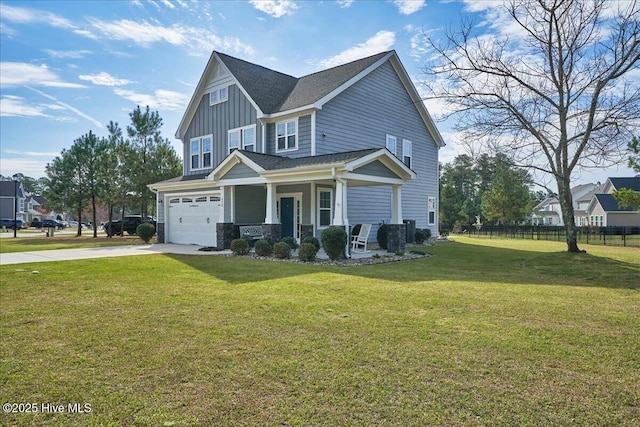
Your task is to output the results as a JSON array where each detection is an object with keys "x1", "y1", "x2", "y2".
[{"x1": 0, "y1": 0, "x2": 633, "y2": 187}]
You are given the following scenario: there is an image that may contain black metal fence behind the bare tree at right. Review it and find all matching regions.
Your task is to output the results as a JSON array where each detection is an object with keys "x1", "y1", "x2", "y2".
[{"x1": 450, "y1": 224, "x2": 640, "y2": 247}]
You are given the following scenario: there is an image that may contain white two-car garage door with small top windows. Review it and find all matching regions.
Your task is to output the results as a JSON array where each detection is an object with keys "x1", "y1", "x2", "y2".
[{"x1": 167, "y1": 195, "x2": 220, "y2": 246}]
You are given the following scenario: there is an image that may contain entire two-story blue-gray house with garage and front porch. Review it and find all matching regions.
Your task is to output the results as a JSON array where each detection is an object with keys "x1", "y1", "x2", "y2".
[{"x1": 150, "y1": 51, "x2": 444, "y2": 250}]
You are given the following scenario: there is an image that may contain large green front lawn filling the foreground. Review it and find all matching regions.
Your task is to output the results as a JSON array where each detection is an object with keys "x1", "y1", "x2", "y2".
[{"x1": 0, "y1": 238, "x2": 640, "y2": 426}]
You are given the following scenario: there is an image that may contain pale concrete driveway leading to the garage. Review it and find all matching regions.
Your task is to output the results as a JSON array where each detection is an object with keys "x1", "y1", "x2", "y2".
[{"x1": 0, "y1": 244, "x2": 231, "y2": 265}]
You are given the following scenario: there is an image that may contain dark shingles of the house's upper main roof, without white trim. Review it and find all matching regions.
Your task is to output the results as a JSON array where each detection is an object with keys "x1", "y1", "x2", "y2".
[{"x1": 217, "y1": 52, "x2": 389, "y2": 114}]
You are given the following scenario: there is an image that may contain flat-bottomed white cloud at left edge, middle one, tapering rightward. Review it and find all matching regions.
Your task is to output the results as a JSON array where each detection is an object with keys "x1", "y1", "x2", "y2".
[{"x1": 0, "y1": 62, "x2": 86, "y2": 89}]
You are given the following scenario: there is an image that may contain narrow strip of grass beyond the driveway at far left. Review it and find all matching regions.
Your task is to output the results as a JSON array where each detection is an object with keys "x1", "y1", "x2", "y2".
[{"x1": 0, "y1": 231, "x2": 146, "y2": 254}]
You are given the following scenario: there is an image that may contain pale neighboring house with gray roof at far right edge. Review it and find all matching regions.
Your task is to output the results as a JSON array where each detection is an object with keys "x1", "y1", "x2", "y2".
[{"x1": 586, "y1": 176, "x2": 640, "y2": 227}]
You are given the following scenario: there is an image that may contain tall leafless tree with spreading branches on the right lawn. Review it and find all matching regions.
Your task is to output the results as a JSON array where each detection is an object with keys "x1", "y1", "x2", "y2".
[{"x1": 425, "y1": 0, "x2": 640, "y2": 252}]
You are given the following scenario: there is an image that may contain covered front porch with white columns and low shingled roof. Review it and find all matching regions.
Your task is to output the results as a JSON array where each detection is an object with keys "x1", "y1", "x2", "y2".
[{"x1": 208, "y1": 148, "x2": 415, "y2": 252}]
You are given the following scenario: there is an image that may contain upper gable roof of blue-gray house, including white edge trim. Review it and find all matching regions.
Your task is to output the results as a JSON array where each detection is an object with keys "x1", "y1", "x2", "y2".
[{"x1": 176, "y1": 50, "x2": 445, "y2": 147}]
